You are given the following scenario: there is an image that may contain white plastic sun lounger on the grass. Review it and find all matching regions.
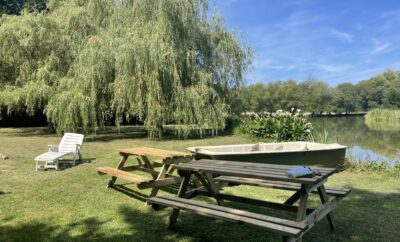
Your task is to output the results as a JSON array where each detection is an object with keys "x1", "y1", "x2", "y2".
[{"x1": 35, "y1": 133, "x2": 84, "y2": 171}]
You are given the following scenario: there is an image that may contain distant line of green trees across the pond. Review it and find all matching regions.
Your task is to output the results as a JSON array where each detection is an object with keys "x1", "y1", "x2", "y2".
[{"x1": 236, "y1": 70, "x2": 400, "y2": 114}]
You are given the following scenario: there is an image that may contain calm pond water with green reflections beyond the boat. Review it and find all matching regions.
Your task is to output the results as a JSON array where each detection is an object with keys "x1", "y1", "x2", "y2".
[{"x1": 311, "y1": 116, "x2": 400, "y2": 164}]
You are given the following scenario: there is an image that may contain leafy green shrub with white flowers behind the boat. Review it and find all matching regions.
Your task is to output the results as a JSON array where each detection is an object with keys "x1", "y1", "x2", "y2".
[{"x1": 239, "y1": 112, "x2": 312, "y2": 142}]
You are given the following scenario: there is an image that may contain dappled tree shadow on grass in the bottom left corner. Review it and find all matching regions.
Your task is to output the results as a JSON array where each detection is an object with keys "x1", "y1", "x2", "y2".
[{"x1": 0, "y1": 209, "x2": 176, "y2": 242}]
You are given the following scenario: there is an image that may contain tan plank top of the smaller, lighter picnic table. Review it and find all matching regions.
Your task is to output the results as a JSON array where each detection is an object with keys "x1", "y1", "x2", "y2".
[{"x1": 118, "y1": 147, "x2": 193, "y2": 159}]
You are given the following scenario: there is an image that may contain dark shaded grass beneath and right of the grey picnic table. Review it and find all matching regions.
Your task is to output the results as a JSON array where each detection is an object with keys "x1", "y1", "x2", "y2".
[{"x1": 141, "y1": 188, "x2": 400, "y2": 241}]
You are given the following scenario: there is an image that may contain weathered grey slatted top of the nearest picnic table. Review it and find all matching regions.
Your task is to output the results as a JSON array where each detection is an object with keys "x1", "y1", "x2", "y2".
[{"x1": 175, "y1": 159, "x2": 337, "y2": 184}]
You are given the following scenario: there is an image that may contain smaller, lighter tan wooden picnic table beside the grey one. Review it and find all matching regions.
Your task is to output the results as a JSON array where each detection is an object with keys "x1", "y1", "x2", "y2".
[{"x1": 96, "y1": 147, "x2": 193, "y2": 197}]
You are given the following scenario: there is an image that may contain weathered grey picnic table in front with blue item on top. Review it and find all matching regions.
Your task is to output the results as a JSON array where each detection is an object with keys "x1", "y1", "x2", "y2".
[{"x1": 148, "y1": 159, "x2": 350, "y2": 241}]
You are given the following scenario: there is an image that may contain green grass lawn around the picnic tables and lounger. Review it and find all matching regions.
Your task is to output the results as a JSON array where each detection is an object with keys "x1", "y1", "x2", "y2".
[{"x1": 0, "y1": 127, "x2": 400, "y2": 241}]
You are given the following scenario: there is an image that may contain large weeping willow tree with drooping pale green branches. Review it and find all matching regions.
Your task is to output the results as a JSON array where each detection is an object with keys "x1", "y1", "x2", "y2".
[{"x1": 0, "y1": 0, "x2": 252, "y2": 137}]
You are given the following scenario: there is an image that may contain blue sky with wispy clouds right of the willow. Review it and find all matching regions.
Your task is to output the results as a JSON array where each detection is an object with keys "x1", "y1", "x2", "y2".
[{"x1": 211, "y1": 0, "x2": 400, "y2": 86}]
